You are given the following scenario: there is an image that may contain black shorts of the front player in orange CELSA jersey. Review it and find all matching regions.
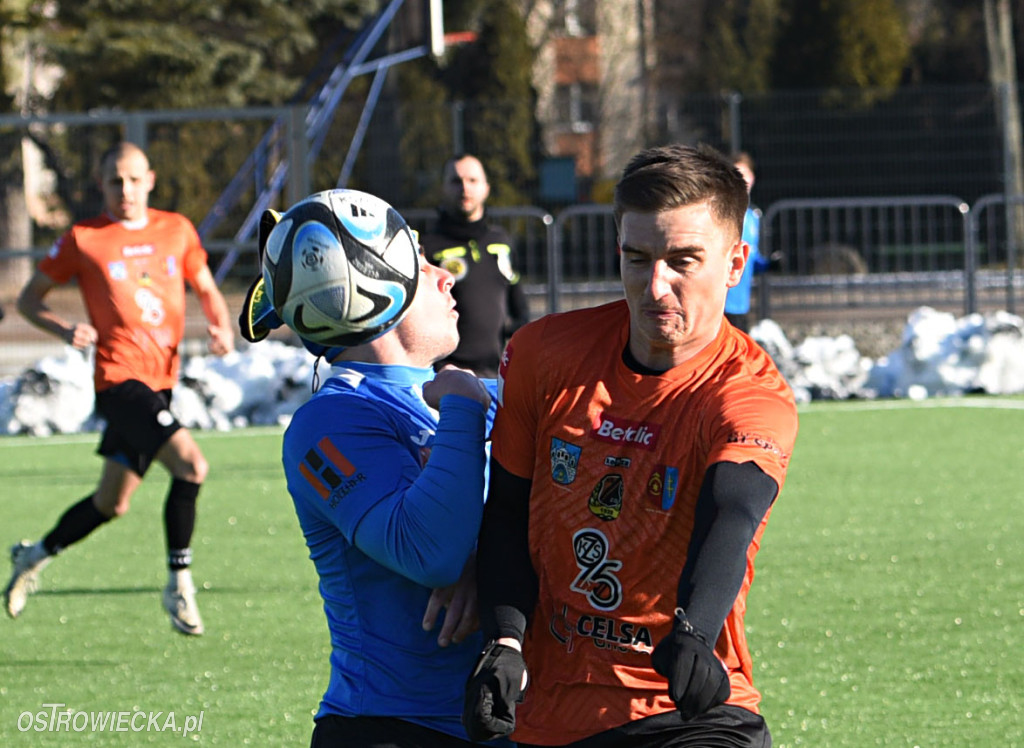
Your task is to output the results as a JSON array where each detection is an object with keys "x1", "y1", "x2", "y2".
[{"x1": 519, "y1": 705, "x2": 771, "y2": 748}]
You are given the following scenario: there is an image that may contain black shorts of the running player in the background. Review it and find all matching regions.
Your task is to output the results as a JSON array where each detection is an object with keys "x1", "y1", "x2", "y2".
[{"x1": 96, "y1": 379, "x2": 181, "y2": 475}]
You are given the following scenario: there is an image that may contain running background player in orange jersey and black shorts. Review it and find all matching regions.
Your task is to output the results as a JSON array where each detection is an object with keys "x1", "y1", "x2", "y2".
[{"x1": 4, "y1": 142, "x2": 234, "y2": 634}]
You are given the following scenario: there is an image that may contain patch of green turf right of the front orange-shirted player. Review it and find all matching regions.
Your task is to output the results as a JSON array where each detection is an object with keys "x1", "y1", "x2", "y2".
[{"x1": 746, "y1": 399, "x2": 1024, "y2": 748}]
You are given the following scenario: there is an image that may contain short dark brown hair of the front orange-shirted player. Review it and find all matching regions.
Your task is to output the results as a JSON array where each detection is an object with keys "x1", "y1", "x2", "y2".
[{"x1": 614, "y1": 144, "x2": 750, "y2": 237}]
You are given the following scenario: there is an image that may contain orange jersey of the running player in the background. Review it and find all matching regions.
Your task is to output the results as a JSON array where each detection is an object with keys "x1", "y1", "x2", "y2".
[{"x1": 39, "y1": 208, "x2": 207, "y2": 391}]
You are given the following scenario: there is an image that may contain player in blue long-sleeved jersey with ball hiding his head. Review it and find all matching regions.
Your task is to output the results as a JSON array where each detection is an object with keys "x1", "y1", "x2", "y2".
[{"x1": 243, "y1": 193, "x2": 493, "y2": 748}]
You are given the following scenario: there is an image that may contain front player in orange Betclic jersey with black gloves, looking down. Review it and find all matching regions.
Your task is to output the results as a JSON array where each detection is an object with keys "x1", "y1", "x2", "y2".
[{"x1": 463, "y1": 146, "x2": 797, "y2": 748}]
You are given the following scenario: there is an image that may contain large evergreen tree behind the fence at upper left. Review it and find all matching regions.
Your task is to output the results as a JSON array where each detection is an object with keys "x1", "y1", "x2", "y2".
[{"x1": 12, "y1": 0, "x2": 379, "y2": 237}]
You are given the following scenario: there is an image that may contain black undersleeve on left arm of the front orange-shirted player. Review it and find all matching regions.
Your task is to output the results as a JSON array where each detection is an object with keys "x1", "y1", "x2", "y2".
[{"x1": 476, "y1": 458, "x2": 538, "y2": 641}]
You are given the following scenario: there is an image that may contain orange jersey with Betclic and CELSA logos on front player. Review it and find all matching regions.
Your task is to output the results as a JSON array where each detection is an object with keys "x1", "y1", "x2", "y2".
[{"x1": 493, "y1": 301, "x2": 797, "y2": 745}]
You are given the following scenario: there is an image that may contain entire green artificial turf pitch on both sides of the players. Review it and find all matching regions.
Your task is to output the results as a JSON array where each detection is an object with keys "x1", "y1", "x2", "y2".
[{"x1": 0, "y1": 398, "x2": 1024, "y2": 748}]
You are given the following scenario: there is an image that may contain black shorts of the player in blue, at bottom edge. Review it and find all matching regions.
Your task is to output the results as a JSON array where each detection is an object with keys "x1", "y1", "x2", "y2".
[{"x1": 309, "y1": 714, "x2": 473, "y2": 748}]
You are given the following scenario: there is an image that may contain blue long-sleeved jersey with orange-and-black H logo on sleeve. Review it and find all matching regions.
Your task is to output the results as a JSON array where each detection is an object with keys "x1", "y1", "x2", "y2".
[{"x1": 283, "y1": 362, "x2": 496, "y2": 739}]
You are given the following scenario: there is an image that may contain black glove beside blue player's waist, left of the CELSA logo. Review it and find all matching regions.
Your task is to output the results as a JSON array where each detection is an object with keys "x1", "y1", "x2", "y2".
[{"x1": 462, "y1": 641, "x2": 527, "y2": 741}]
